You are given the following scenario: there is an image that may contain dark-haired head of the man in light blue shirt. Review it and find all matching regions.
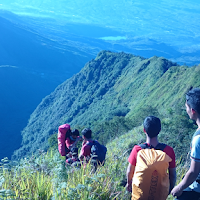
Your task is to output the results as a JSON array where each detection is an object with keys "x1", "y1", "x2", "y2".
[{"x1": 186, "y1": 88, "x2": 200, "y2": 114}]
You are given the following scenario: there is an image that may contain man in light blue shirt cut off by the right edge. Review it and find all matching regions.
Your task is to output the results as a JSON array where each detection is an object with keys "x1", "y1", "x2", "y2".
[{"x1": 171, "y1": 88, "x2": 200, "y2": 200}]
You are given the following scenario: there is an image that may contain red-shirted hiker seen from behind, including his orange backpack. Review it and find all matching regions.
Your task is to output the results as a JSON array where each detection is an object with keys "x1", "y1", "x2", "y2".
[{"x1": 126, "y1": 116, "x2": 176, "y2": 200}]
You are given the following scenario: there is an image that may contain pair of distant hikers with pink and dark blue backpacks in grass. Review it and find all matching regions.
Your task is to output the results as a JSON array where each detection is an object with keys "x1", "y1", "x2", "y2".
[{"x1": 58, "y1": 124, "x2": 107, "y2": 167}]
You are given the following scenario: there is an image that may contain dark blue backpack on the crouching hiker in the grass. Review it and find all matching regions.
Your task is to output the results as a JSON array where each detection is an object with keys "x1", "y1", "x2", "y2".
[{"x1": 89, "y1": 140, "x2": 107, "y2": 165}]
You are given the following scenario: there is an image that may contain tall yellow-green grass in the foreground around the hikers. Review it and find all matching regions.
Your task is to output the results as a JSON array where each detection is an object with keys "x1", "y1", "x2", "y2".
[{"x1": 0, "y1": 127, "x2": 191, "y2": 200}]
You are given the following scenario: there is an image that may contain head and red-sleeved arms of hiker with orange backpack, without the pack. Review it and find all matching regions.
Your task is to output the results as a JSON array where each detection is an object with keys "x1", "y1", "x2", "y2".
[{"x1": 126, "y1": 116, "x2": 176, "y2": 195}]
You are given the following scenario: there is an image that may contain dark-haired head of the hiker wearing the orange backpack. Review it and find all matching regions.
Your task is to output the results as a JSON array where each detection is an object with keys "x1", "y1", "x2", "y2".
[{"x1": 143, "y1": 116, "x2": 161, "y2": 138}]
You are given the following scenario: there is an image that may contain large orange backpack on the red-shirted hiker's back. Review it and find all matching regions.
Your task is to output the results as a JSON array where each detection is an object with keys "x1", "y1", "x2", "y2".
[{"x1": 132, "y1": 143, "x2": 172, "y2": 200}]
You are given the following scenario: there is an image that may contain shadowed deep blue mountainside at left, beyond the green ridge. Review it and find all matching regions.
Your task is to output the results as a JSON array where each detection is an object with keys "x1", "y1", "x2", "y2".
[{"x1": 0, "y1": 12, "x2": 92, "y2": 159}]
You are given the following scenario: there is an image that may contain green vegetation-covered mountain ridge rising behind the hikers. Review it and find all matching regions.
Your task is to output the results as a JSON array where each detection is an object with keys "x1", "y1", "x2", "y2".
[{"x1": 13, "y1": 51, "x2": 200, "y2": 159}]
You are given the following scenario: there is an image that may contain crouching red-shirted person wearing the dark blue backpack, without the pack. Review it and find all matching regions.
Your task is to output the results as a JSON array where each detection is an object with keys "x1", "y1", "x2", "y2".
[{"x1": 79, "y1": 128, "x2": 93, "y2": 162}]
